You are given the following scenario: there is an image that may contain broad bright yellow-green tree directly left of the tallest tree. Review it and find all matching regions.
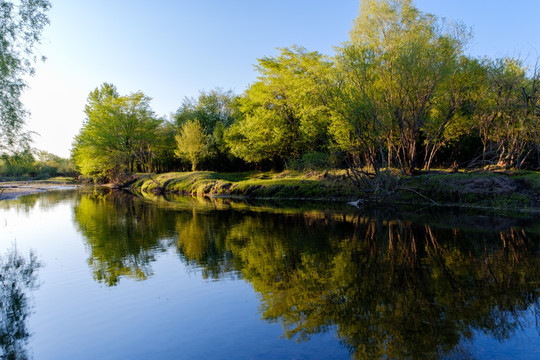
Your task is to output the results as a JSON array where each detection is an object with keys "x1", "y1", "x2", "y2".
[{"x1": 226, "y1": 47, "x2": 330, "y2": 164}]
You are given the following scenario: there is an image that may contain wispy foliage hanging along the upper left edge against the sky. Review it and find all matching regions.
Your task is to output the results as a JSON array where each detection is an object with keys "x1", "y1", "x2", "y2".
[{"x1": 0, "y1": 0, "x2": 51, "y2": 150}]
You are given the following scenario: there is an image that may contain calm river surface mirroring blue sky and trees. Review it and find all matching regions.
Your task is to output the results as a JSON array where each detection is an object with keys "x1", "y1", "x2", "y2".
[{"x1": 0, "y1": 190, "x2": 540, "y2": 359}]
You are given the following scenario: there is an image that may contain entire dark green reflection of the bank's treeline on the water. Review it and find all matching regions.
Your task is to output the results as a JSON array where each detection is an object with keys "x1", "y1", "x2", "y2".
[{"x1": 70, "y1": 192, "x2": 540, "y2": 359}]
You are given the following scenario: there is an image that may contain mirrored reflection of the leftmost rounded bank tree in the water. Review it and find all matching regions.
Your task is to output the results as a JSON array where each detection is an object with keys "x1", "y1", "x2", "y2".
[{"x1": 74, "y1": 189, "x2": 174, "y2": 286}]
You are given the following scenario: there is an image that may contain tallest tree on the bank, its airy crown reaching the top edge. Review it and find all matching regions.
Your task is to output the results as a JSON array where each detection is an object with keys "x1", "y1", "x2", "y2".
[{"x1": 333, "y1": 0, "x2": 468, "y2": 174}]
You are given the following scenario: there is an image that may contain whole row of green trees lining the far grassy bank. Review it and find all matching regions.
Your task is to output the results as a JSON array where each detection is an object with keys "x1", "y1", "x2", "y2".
[{"x1": 72, "y1": 0, "x2": 540, "y2": 180}]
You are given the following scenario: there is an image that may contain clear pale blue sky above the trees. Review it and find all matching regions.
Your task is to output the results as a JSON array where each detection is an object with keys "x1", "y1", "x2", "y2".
[{"x1": 23, "y1": 0, "x2": 540, "y2": 157}]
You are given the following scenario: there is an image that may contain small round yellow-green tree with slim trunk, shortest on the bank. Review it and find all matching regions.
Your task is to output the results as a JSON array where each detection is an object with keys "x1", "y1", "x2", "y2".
[{"x1": 175, "y1": 120, "x2": 208, "y2": 171}]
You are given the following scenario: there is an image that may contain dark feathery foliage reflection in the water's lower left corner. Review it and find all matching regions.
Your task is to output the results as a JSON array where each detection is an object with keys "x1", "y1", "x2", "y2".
[{"x1": 0, "y1": 247, "x2": 41, "y2": 359}]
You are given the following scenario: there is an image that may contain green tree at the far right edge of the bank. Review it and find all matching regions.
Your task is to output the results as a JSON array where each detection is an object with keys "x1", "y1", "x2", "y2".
[{"x1": 474, "y1": 58, "x2": 540, "y2": 169}]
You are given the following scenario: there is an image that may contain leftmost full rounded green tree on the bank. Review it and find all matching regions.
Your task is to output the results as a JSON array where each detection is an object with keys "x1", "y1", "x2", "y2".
[{"x1": 72, "y1": 83, "x2": 162, "y2": 180}]
